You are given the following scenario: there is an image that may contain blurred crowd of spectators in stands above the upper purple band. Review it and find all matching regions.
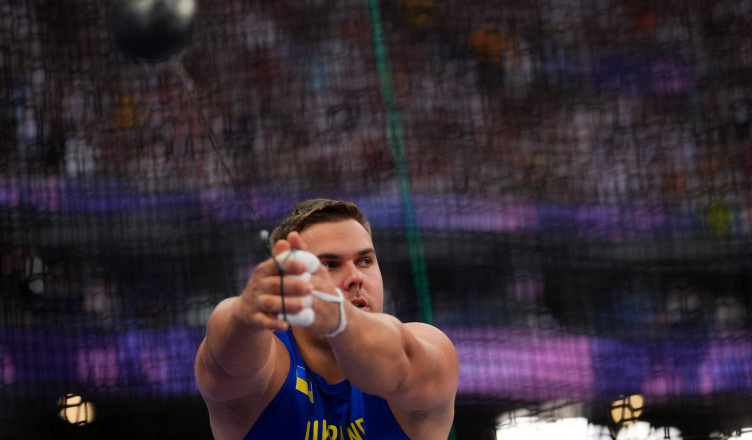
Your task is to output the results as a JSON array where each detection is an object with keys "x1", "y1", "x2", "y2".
[{"x1": 0, "y1": 0, "x2": 752, "y2": 332}]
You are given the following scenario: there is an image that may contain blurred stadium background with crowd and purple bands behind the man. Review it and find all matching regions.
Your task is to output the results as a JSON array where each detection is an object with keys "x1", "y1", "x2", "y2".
[{"x1": 0, "y1": 0, "x2": 752, "y2": 440}]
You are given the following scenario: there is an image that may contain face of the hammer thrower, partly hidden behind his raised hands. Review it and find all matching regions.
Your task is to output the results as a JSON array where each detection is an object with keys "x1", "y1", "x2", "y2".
[{"x1": 300, "y1": 219, "x2": 384, "y2": 312}]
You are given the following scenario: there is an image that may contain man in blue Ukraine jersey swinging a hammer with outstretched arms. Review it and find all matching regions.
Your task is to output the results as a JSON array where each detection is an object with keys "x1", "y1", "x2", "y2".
[{"x1": 196, "y1": 199, "x2": 459, "y2": 440}]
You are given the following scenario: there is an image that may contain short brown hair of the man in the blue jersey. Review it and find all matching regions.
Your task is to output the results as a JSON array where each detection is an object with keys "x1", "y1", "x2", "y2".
[{"x1": 269, "y1": 198, "x2": 371, "y2": 245}]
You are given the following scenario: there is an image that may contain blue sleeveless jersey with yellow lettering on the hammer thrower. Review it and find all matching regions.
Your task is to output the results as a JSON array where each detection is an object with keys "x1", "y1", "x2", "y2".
[{"x1": 245, "y1": 331, "x2": 409, "y2": 440}]
